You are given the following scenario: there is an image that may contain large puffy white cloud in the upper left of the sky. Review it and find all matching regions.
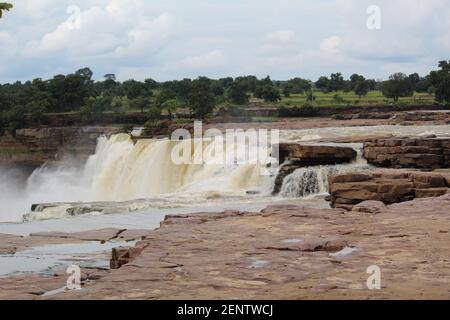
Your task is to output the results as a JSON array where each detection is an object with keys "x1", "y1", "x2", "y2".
[{"x1": 25, "y1": 0, "x2": 173, "y2": 59}]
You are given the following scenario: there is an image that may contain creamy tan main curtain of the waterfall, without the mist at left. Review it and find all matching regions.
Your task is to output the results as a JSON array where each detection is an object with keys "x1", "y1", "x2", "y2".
[{"x1": 84, "y1": 135, "x2": 265, "y2": 201}]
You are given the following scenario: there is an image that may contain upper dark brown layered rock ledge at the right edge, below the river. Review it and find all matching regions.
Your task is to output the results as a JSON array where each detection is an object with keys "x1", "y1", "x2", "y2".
[{"x1": 363, "y1": 137, "x2": 450, "y2": 170}]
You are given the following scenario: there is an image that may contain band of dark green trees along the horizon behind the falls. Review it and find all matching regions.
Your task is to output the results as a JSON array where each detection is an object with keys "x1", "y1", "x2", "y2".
[{"x1": 0, "y1": 61, "x2": 450, "y2": 135}]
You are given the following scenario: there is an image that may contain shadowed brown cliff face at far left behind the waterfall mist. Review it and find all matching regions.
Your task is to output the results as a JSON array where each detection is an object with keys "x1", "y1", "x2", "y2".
[{"x1": 0, "y1": 127, "x2": 118, "y2": 167}]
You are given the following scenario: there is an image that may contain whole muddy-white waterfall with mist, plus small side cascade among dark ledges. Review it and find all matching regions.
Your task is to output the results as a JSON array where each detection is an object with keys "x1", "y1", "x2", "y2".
[{"x1": 2, "y1": 134, "x2": 370, "y2": 220}]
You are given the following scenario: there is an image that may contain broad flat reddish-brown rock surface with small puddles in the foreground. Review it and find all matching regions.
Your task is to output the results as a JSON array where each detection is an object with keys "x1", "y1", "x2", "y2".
[{"x1": 0, "y1": 195, "x2": 442, "y2": 299}]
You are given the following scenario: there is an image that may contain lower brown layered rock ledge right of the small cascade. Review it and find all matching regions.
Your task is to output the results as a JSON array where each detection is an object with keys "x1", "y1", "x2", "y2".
[{"x1": 329, "y1": 169, "x2": 450, "y2": 210}]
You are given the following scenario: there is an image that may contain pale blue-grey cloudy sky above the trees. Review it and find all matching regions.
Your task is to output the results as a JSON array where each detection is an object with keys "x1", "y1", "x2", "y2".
[{"x1": 0, "y1": 0, "x2": 450, "y2": 83}]
